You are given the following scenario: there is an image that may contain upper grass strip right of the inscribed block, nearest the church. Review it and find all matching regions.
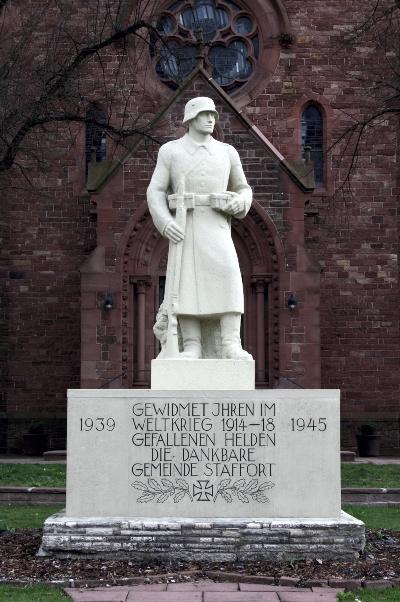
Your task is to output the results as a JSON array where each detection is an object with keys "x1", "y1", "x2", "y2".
[{"x1": 342, "y1": 462, "x2": 400, "y2": 488}]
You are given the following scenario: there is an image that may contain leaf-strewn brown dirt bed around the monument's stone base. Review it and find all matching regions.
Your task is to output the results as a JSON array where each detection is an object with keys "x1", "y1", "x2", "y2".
[{"x1": 0, "y1": 529, "x2": 400, "y2": 584}]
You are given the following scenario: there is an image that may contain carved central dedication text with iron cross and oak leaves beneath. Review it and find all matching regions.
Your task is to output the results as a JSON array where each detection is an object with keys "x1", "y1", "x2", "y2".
[{"x1": 131, "y1": 401, "x2": 277, "y2": 504}]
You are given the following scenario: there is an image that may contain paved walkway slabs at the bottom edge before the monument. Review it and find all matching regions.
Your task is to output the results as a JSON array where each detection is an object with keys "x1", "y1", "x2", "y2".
[{"x1": 65, "y1": 581, "x2": 344, "y2": 602}]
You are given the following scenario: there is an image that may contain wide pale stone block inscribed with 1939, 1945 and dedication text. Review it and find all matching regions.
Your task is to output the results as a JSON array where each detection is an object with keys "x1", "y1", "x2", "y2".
[{"x1": 67, "y1": 389, "x2": 341, "y2": 520}]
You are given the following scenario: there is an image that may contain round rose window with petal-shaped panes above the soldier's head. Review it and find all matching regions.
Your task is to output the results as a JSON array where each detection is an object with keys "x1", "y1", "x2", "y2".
[{"x1": 152, "y1": 0, "x2": 260, "y2": 91}]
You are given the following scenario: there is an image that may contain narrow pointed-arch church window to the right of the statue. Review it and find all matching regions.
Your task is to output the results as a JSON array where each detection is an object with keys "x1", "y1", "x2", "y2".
[{"x1": 301, "y1": 104, "x2": 325, "y2": 186}]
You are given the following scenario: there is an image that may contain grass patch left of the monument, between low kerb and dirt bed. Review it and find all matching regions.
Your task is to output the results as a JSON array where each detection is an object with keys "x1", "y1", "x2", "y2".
[{"x1": 0, "y1": 504, "x2": 64, "y2": 528}]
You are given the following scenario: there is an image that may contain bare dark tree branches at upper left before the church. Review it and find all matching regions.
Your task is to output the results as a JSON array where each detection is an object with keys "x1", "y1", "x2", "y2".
[{"x1": 0, "y1": 0, "x2": 161, "y2": 172}]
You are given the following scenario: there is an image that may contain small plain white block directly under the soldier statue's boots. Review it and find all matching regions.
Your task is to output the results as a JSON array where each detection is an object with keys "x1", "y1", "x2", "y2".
[{"x1": 151, "y1": 359, "x2": 255, "y2": 391}]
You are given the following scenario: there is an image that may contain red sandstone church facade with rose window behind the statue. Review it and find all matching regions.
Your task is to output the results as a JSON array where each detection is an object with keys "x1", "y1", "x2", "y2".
[{"x1": 0, "y1": 0, "x2": 400, "y2": 455}]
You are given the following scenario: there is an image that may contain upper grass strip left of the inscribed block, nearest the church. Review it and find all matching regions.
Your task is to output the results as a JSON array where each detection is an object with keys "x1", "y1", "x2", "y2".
[{"x1": 0, "y1": 464, "x2": 66, "y2": 487}]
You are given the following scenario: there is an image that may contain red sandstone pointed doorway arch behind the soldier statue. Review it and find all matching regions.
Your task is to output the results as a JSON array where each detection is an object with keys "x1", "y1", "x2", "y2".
[{"x1": 116, "y1": 197, "x2": 285, "y2": 388}]
